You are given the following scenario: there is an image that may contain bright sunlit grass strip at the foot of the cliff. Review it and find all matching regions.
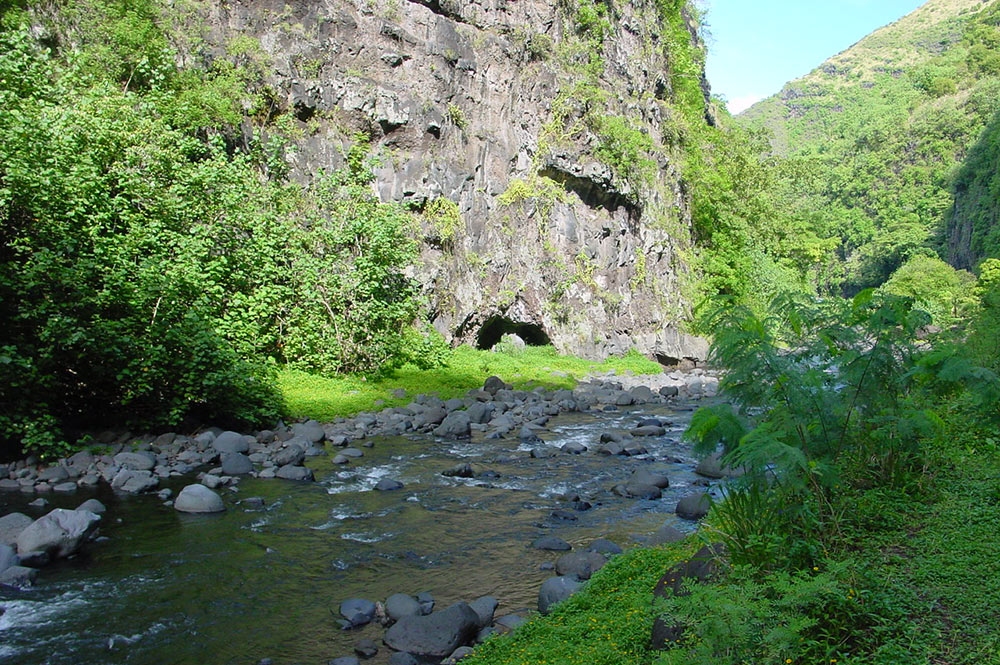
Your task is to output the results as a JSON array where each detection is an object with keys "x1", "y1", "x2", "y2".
[{"x1": 278, "y1": 346, "x2": 663, "y2": 421}]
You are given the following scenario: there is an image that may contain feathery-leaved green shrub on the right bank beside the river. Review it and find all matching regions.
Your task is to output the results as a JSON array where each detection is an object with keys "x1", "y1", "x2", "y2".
[{"x1": 686, "y1": 290, "x2": 998, "y2": 567}]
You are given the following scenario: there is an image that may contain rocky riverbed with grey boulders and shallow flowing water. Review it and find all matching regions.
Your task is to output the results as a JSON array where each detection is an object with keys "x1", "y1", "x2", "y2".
[{"x1": 0, "y1": 371, "x2": 724, "y2": 663}]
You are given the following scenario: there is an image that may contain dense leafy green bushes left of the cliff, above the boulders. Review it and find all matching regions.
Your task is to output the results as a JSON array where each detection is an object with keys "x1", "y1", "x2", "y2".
[{"x1": 0, "y1": 0, "x2": 427, "y2": 452}]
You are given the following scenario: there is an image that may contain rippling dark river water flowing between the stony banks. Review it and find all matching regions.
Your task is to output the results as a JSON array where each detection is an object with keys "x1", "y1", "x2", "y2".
[{"x1": 0, "y1": 396, "x2": 720, "y2": 665}]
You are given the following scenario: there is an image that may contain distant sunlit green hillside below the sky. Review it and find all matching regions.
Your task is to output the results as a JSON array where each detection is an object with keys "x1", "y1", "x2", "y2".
[{"x1": 738, "y1": 0, "x2": 1000, "y2": 294}]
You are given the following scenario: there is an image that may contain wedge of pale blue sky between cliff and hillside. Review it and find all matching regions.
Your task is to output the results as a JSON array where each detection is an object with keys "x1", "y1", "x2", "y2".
[{"x1": 700, "y1": 0, "x2": 924, "y2": 113}]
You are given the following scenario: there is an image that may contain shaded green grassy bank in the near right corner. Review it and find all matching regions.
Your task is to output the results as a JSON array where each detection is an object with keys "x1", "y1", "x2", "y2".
[{"x1": 458, "y1": 433, "x2": 1000, "y2": 665}]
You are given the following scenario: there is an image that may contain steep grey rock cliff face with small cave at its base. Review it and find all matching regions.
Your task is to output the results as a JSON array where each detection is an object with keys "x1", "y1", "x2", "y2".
[{"x1": 208, "y1": 0, "x2": 707, "y2": 362}]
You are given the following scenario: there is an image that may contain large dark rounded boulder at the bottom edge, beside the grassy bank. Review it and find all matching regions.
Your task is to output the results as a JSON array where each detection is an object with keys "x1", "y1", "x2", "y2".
[{"x1": 384, "y1": 603, "x2": 479, "y2": 658}]
